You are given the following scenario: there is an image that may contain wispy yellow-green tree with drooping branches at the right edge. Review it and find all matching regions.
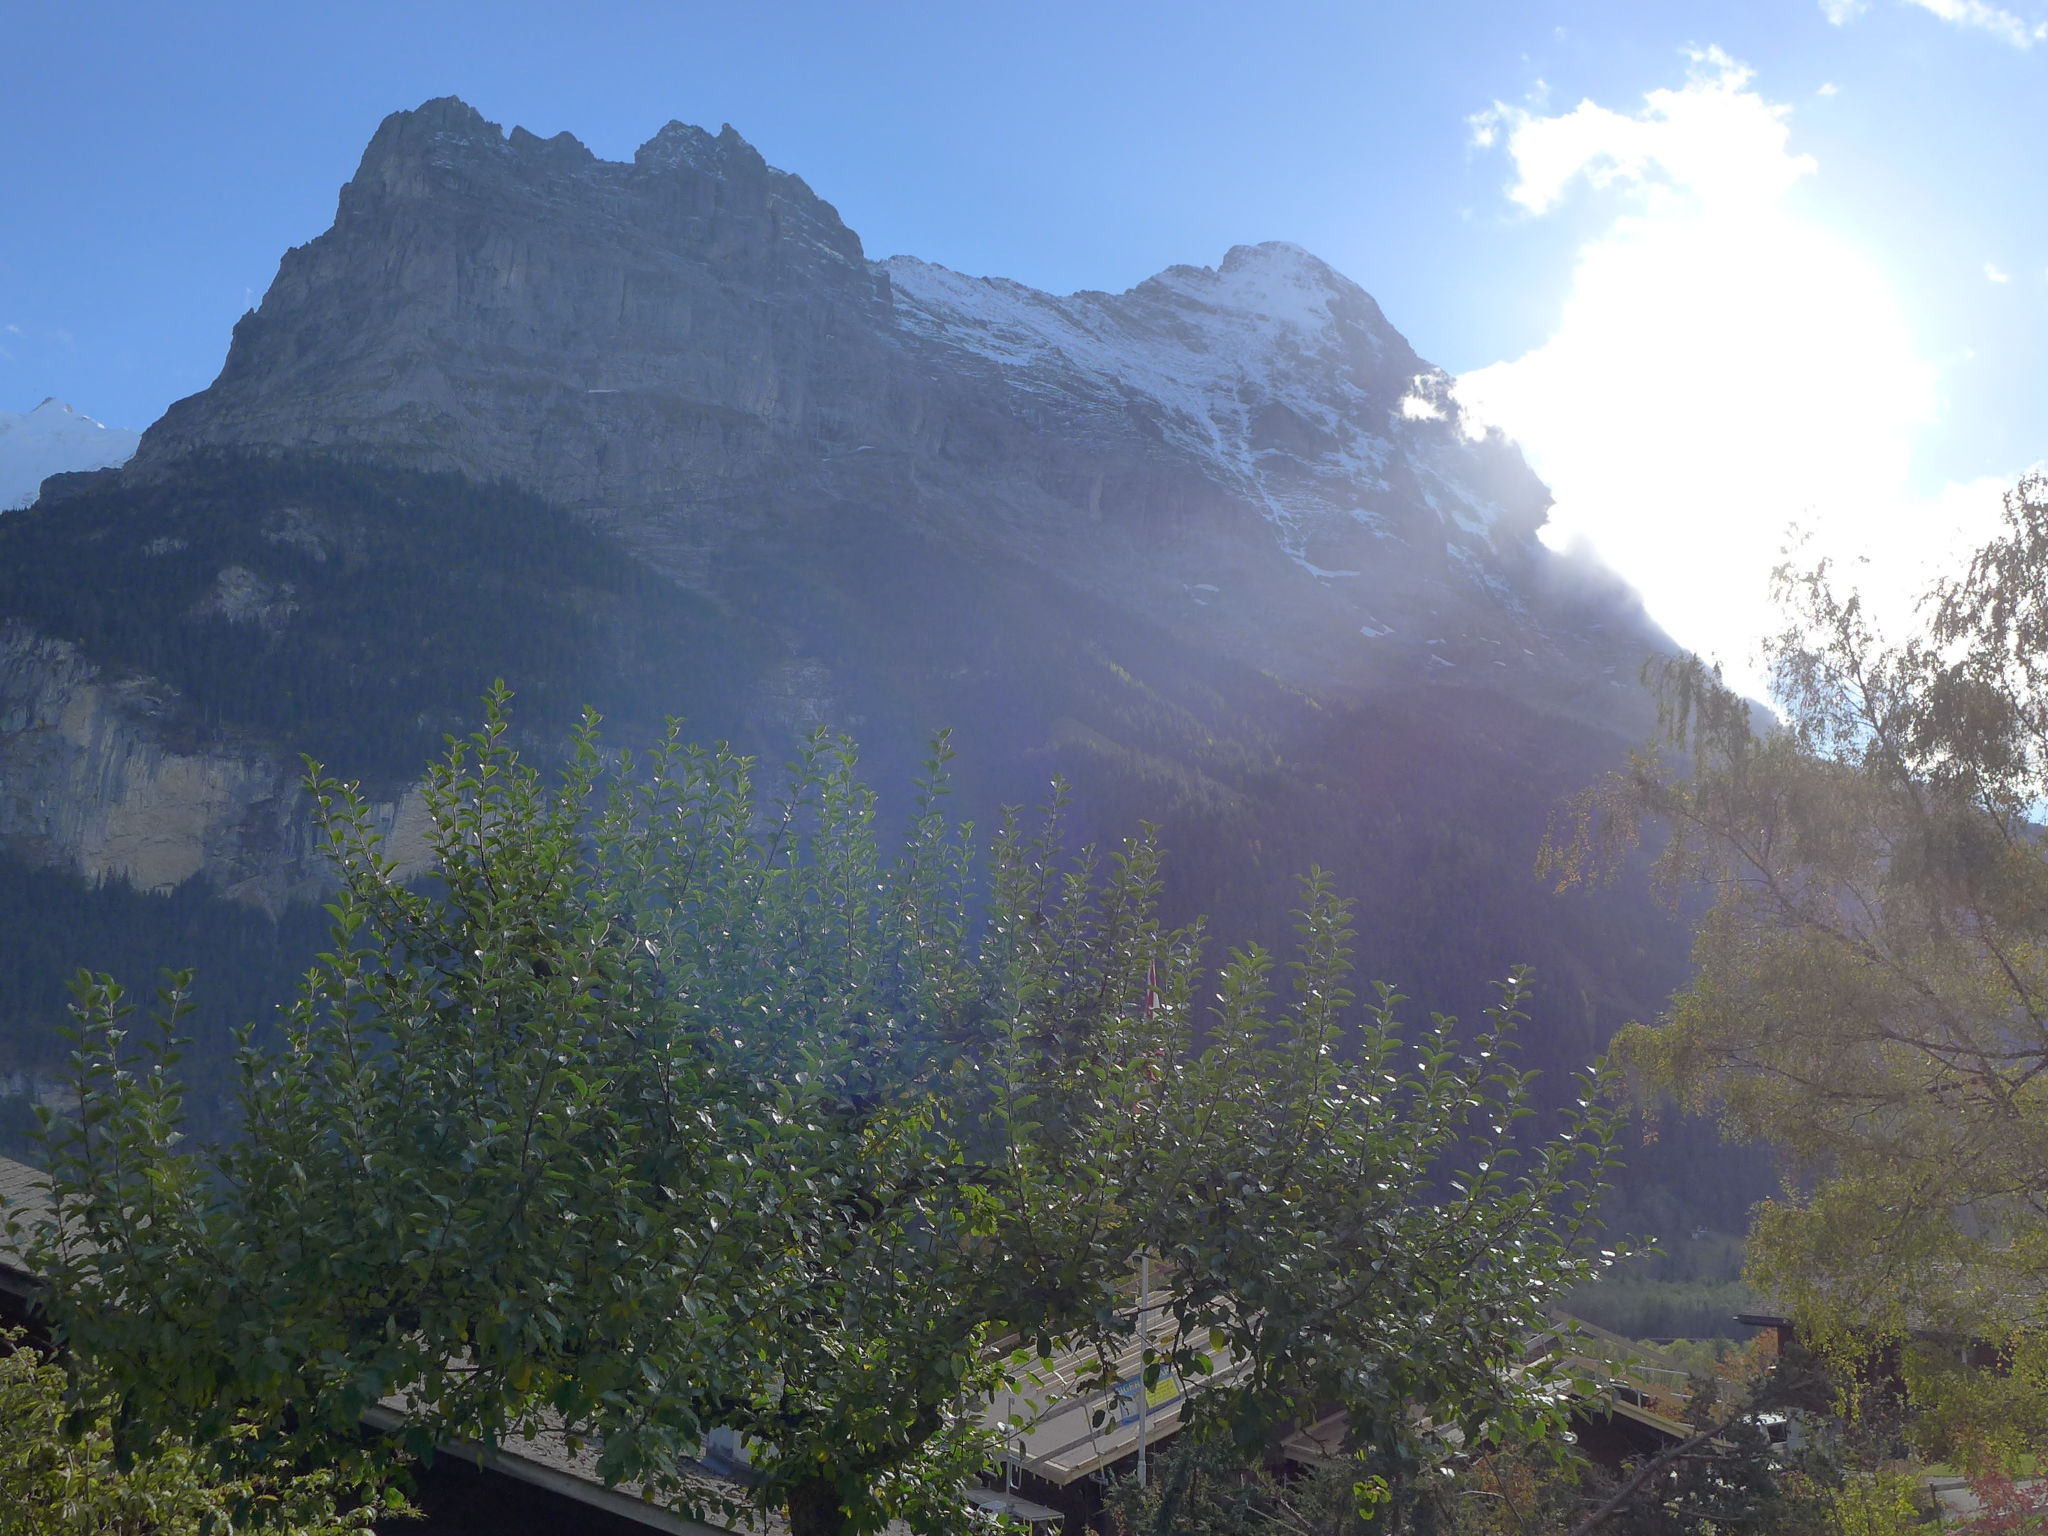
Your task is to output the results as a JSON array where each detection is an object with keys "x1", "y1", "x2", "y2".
[{"x1": 1550, "y1": 479, "x2": 2048, "y2": 1417}]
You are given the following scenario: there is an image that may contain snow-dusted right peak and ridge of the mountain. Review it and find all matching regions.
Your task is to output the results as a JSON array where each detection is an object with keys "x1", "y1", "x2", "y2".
[{"x1": 885, "y1": 242, "x2": 1528, "y2": 580}]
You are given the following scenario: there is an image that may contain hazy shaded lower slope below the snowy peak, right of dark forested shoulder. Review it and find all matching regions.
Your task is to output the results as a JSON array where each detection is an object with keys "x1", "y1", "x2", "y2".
[{"x1": 696, "y1": 493, "x2": 1683, "y2": 1061}]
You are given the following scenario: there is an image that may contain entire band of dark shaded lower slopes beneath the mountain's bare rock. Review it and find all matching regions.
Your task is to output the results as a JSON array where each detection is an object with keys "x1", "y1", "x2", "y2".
[{"x1": 12, "y1": 457, "x2": 1679, "y2": 1028}]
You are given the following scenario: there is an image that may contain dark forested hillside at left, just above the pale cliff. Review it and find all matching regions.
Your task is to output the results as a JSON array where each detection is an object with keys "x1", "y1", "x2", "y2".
[{"x1": 0, "y1": 455, "x2": 748, "y2": 788}]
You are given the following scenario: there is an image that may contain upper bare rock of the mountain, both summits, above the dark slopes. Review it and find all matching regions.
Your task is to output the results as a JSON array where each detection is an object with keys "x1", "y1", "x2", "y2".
[{"x1": 131, "y1": 98, "x2": 1649, "y2": 715}]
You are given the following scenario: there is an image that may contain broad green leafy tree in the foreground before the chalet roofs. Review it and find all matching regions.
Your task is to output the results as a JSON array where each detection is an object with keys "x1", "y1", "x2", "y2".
[{"x1": 39, "y1": 692, "x2": 1612, "y2": 1536}]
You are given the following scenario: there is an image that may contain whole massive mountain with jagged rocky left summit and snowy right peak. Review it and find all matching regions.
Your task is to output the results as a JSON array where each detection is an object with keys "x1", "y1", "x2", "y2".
[{"x1": 0, "y1": 98, "x2": 1744, "y2": 1228}]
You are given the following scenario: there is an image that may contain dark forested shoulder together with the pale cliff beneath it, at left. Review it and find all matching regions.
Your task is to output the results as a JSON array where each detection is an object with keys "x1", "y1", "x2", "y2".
[{"x1": 0, "y1": 459, "x2": 733, "y2": 911}]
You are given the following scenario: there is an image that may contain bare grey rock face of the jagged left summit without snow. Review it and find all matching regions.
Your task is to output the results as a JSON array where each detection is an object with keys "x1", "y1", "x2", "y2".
[{"x1": 145, "y1": 98, "x2": 889, "y2": 552}]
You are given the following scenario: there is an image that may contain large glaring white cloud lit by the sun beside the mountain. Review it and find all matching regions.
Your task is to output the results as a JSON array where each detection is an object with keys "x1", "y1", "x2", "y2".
[{"x1": 1456, "y1": 49, "x2": 2007, "y2": 686}]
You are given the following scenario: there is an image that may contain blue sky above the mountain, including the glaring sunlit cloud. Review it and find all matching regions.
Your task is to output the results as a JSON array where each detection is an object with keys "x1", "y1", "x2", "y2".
[{"x1": 0, "y1": 0, "x2": 2048, "y2": 666}]
